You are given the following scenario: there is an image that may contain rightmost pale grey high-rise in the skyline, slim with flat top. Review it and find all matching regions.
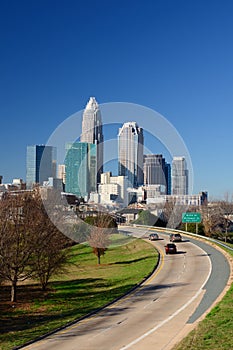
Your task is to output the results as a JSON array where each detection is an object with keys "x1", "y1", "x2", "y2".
[{"x1": 172, "y1": 157, "x2": 188, "y2": 195}]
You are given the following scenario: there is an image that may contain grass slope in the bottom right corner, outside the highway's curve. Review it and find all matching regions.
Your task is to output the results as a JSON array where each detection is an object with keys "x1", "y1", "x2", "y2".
[{"x1": 174, "y1": 245, "x2": 233, "y2": 350}]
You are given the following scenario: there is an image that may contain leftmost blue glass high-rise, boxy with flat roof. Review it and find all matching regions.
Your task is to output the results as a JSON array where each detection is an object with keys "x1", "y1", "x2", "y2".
[{"x1": 26, "y1": 145, "x2": 56, "y2": 188}]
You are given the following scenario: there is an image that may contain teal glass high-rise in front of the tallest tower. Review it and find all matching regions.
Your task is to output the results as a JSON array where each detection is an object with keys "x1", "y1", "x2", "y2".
[{"x1": 65, "y1": 142, "x2": 97, "y2": 199}]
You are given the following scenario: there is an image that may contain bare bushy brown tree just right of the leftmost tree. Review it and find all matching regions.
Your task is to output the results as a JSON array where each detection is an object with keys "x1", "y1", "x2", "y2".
[{"x1": 26, "y1": 190, "x2": 72, "y2": 290}]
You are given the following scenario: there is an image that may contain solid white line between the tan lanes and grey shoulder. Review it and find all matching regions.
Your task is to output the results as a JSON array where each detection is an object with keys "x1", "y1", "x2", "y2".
[{"x1": 120, "y1": 252, "x2": 212, "y2": 350}]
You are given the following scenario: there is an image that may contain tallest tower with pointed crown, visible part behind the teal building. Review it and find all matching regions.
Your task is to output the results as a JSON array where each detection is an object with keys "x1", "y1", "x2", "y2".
[{"x1": 80, "y1": 97, "x2": 104, "y2": 184}]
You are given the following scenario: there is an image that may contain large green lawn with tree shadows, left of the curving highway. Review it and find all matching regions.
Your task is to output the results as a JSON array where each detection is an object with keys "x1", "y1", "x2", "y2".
[{"x1": 0, "y1": 234, "x2": 158, "y2": 350}]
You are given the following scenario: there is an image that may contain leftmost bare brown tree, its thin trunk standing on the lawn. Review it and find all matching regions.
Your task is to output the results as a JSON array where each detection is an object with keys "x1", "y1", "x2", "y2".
[{"x1": 0, "y1": 194, "x2": 34, "y2": 302}]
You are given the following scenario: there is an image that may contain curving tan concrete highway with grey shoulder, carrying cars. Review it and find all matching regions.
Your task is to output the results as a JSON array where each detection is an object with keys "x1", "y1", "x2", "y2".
[{"x1": 24, "y1": 228, "x2": 230, "y2": 350}]
